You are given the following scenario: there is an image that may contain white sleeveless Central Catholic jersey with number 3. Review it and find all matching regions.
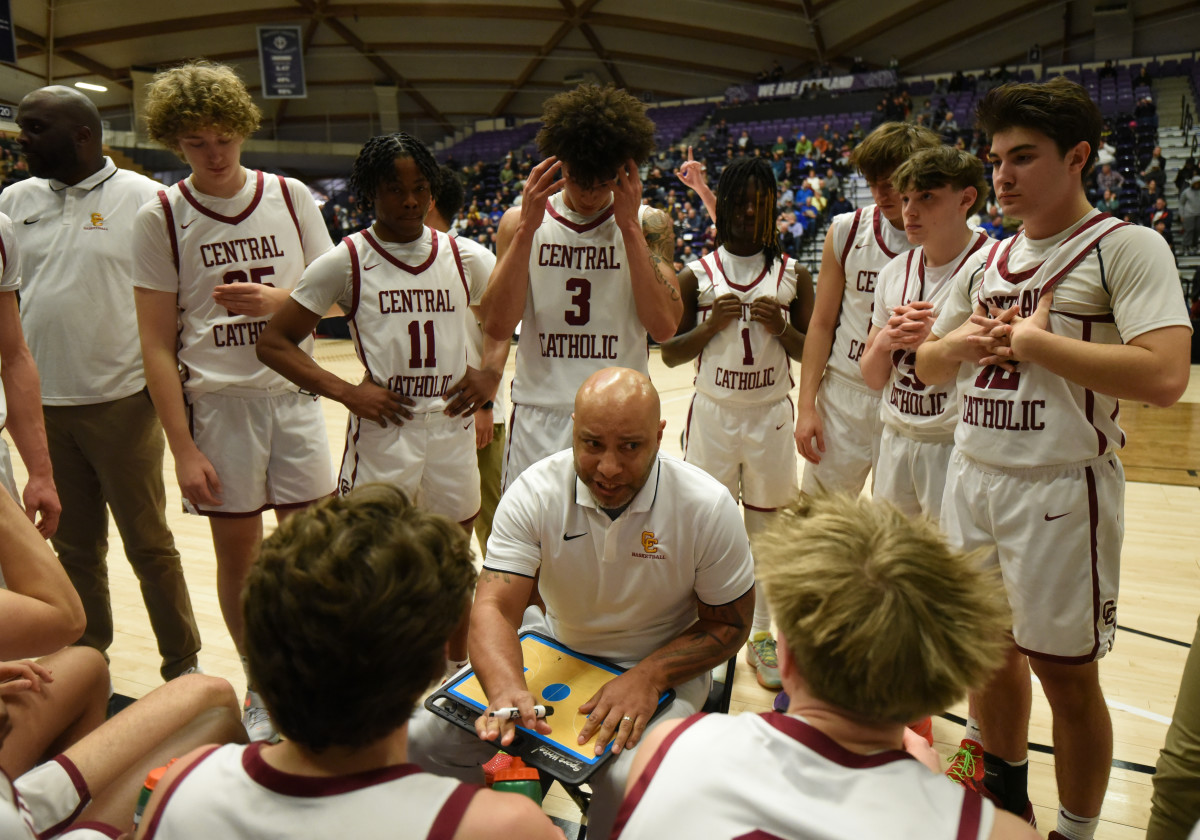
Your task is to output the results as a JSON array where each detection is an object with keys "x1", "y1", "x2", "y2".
[{"x1": 512, "y1": 192, "x2": 649, "y2": 410}]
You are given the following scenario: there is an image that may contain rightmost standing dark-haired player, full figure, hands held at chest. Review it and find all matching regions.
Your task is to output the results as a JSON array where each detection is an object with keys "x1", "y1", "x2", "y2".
[{"x1": 917, "y1": 78, "x2": 1190, "y2": 840}]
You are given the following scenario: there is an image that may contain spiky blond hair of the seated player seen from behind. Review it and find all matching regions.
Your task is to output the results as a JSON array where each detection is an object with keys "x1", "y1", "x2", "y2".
[{"x1": 755, "y1": 496, "x2": 1012, "y2": 724}]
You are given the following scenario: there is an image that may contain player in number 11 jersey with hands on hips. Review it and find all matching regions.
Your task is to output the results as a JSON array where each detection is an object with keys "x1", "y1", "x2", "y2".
[{"x1": 258, "y1": 133, "x2": 504, "y2": 668}]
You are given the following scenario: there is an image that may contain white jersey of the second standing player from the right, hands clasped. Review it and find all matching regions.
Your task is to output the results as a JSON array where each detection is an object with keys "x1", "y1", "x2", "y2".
[{"x1": 871, "y1": 232, "x2": 995, "y2": 442}]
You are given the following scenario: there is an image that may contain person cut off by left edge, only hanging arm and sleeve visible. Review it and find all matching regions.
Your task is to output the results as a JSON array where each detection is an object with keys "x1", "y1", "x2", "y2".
[{"x1": 0, "y1": 212, "x2": 62, "y2": 535}]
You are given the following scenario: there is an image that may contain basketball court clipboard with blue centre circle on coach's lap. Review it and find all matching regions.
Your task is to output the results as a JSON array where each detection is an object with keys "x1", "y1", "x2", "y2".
[{"x1": 425, "y1": 631, "x2": 674, "y2": 785}]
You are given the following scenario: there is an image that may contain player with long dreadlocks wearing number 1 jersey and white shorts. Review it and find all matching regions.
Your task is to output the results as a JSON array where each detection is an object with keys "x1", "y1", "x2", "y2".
[{"x1": 662, "y1": 157, "x2": 812, "y2": 689}]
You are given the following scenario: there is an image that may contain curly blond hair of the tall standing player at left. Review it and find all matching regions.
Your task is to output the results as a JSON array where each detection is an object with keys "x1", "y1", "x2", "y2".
[{"x1": 145, "y1": 59, "x2": 263, "y2": 157}]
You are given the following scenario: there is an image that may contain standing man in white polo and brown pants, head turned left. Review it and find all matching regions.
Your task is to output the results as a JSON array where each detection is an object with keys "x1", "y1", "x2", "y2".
[{"x1": 0, "y1": 85, "x2": 200, "y2": 679}]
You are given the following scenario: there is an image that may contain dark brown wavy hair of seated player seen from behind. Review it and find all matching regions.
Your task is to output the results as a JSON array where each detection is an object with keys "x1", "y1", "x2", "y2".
[{"x1": 242, "y1": 484, "x2": 475, "y2": 752}]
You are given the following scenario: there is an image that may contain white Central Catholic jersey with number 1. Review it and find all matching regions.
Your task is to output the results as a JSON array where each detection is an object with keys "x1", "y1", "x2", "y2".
[{"x1": 689, "y1": 246, "x2": 796, "y2": 406}]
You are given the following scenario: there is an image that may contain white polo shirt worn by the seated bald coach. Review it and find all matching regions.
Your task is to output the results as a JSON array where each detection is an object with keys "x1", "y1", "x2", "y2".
[{"x1": 484, "y1": 449, "x2": 754, "y2": 665}]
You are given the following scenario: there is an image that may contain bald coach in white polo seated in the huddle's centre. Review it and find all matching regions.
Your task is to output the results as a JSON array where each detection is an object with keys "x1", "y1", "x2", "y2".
[{"x1": 409, "y1": 368, "x2": 754, "y2": 840}]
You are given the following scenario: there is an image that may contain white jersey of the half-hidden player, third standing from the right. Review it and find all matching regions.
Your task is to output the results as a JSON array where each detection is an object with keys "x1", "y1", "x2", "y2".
[{"x1": 826, "y1": 204, "x2": 912, "y2": 394}]
